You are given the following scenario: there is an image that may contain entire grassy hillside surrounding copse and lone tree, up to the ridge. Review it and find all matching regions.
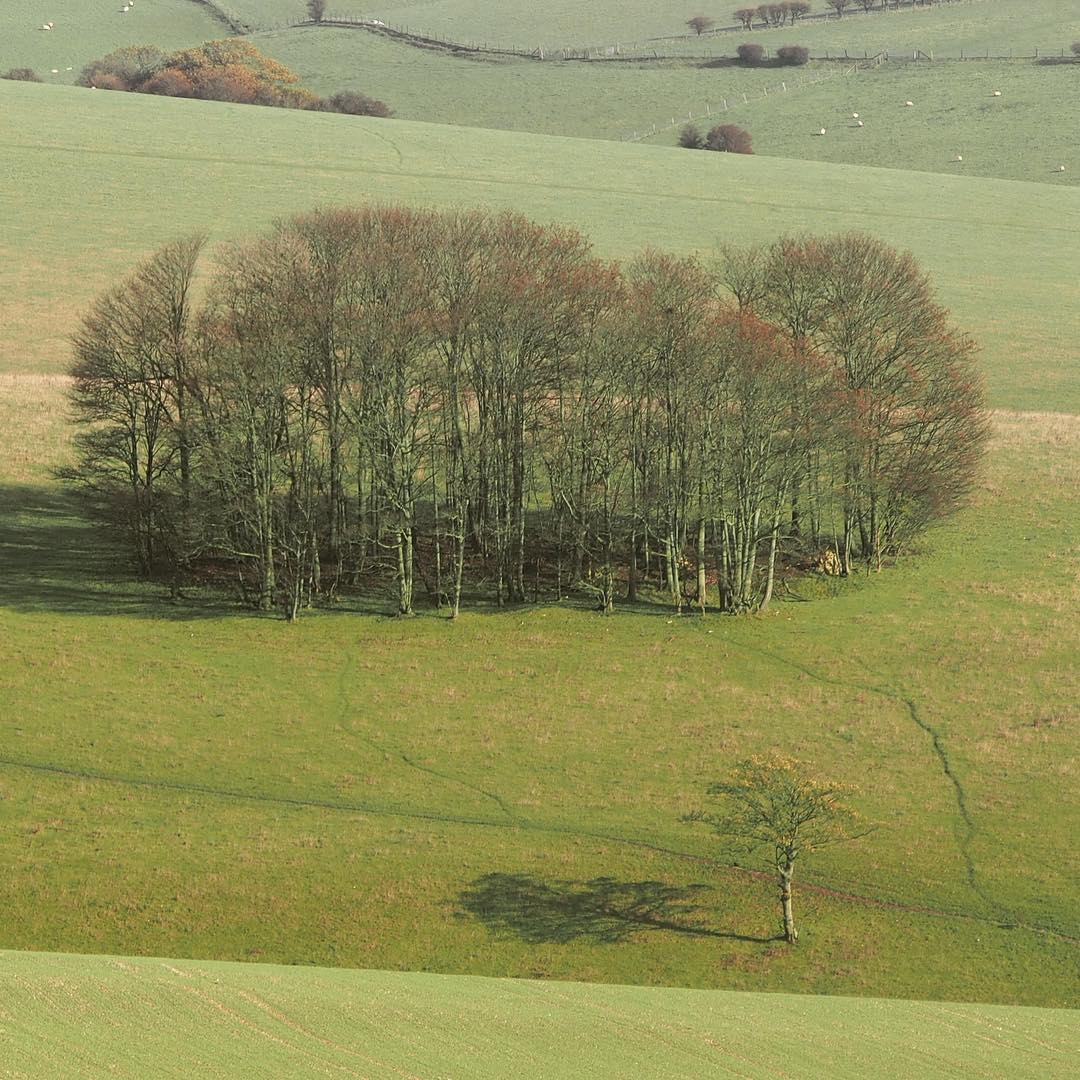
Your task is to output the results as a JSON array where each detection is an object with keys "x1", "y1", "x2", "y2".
[{"x1": 0, "y1": 78, "x2": 1080, "y2": 1007}]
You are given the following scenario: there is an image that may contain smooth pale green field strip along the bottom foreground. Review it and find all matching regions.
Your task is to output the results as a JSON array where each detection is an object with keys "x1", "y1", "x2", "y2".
[{"x1": 0, "y1": 953, "x2": 1080, "y2": 1080}]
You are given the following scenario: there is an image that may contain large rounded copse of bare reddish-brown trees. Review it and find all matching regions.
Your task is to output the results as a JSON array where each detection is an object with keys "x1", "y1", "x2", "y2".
[{"x1": 69, "y1": 207, "x2": 985, "y2": 619}]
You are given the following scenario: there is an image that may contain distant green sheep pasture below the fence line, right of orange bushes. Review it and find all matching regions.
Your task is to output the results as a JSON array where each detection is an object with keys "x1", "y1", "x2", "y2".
[{"x1": 245, "y1": 27, "x2": 1080, "y2": 185}]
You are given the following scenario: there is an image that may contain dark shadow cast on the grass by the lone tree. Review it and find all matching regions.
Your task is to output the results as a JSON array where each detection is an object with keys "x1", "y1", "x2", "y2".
[{"x1": 459, "y1": 874, "x2": 771, "y2": 945}]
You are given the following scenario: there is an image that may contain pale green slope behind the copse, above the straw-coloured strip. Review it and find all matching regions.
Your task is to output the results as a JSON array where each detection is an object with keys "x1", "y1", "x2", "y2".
[{"x1": 0, "y1": 83, "x2": 1080, "y2": 410}]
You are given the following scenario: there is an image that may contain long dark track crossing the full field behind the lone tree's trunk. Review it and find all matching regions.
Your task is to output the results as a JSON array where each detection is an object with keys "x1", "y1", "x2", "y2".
[{"x1": 0, "y1": 757, "x2": 1080, "y2": 945}]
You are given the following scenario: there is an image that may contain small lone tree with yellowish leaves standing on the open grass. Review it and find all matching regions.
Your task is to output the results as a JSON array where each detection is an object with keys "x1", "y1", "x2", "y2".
[{"x1": 684, "y1": 755, "x2": 869, "y2": 945}]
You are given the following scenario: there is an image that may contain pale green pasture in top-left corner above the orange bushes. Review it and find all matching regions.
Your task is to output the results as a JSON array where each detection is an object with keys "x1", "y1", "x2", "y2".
[{"x1": 0, "y1": 0, "x2": 228, "y2": 84}]
